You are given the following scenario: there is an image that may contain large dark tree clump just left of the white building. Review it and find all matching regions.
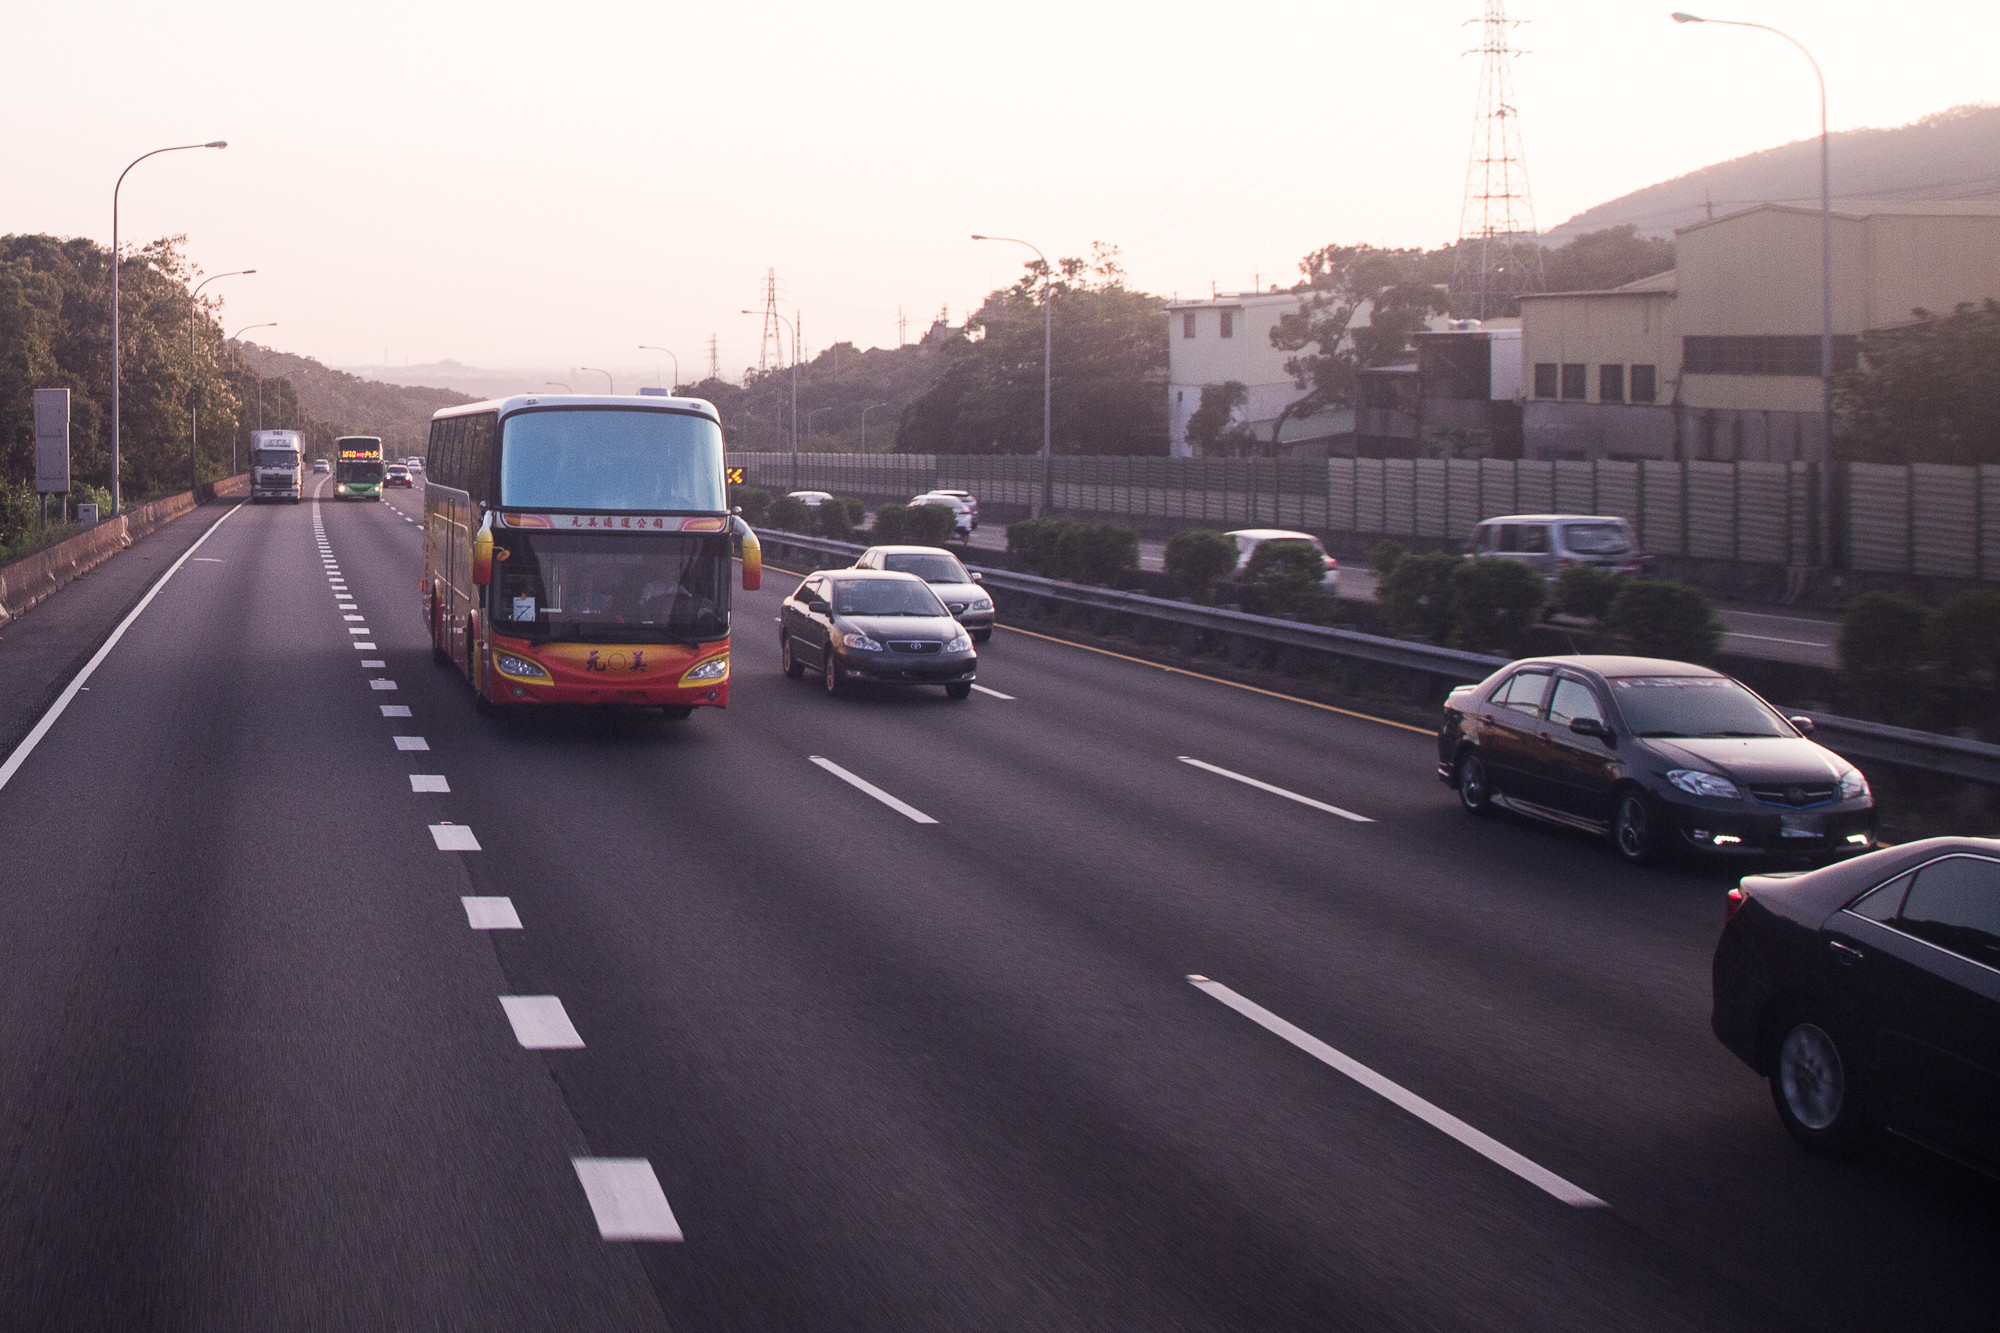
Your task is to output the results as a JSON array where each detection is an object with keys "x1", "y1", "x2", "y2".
[{"x1": 896, "y1": 242, "x2": 1166, "y2": 454}]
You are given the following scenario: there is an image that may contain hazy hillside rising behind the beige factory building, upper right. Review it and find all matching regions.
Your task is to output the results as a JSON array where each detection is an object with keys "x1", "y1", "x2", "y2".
[{"x1": 1544, "y1": 106, "x2": 2000, "y2": 240}]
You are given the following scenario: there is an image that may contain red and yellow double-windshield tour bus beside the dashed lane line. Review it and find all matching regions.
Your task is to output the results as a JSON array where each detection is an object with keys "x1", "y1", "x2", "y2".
[{"x1": 418, "y1": 394, "x2": 762, "y2": 717}]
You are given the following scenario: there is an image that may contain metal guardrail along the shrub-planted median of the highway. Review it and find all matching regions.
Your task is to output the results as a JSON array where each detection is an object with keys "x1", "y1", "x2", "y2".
[{"x1": 758, "y1": 532, "x2": 2000, "y2": 787}]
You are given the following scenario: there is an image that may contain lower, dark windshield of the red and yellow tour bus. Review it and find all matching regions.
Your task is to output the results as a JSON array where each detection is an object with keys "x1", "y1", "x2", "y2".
[{"x1": 492, "y1": 530, "x2": 730, "y2": 642}]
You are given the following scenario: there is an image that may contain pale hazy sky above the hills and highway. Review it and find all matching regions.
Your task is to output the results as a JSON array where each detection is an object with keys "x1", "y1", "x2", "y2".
[{"x1": 0, "y1": 0, "x2": 2000, "y2": 378}]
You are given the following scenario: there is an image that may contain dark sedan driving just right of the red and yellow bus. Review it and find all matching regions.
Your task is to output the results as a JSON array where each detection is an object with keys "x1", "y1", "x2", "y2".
[{"x1": 778, "y1": 568, "x2": 980, "y2": 699}]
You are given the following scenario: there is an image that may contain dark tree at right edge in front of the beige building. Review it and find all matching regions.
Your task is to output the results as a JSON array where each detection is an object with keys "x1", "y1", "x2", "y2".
[{"x1": 1834, "y1": 298, "x2": 2000, "y2": 466}]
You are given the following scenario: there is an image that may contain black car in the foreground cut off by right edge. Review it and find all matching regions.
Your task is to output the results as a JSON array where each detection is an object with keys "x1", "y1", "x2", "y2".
[{"x1": 1710, "y1": 839, "x2": 2000, "y2": 1175}]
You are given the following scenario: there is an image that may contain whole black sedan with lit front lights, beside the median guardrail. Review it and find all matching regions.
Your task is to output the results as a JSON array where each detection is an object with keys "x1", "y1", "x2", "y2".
[{"x1": 1438, "y1": 656, "x2": 1876, "y2": 863}]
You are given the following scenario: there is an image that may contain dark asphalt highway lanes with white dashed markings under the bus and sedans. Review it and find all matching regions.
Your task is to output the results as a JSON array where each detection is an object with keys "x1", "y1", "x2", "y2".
[{"x1": 0, "y1": 478, "x2": 2000, "y2": 1331}]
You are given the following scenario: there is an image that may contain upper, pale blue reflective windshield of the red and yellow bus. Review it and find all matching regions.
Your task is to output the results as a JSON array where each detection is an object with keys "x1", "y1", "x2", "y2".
[{"x1": 500, "y1": 408, "x2": 728, "y2": 514}]
